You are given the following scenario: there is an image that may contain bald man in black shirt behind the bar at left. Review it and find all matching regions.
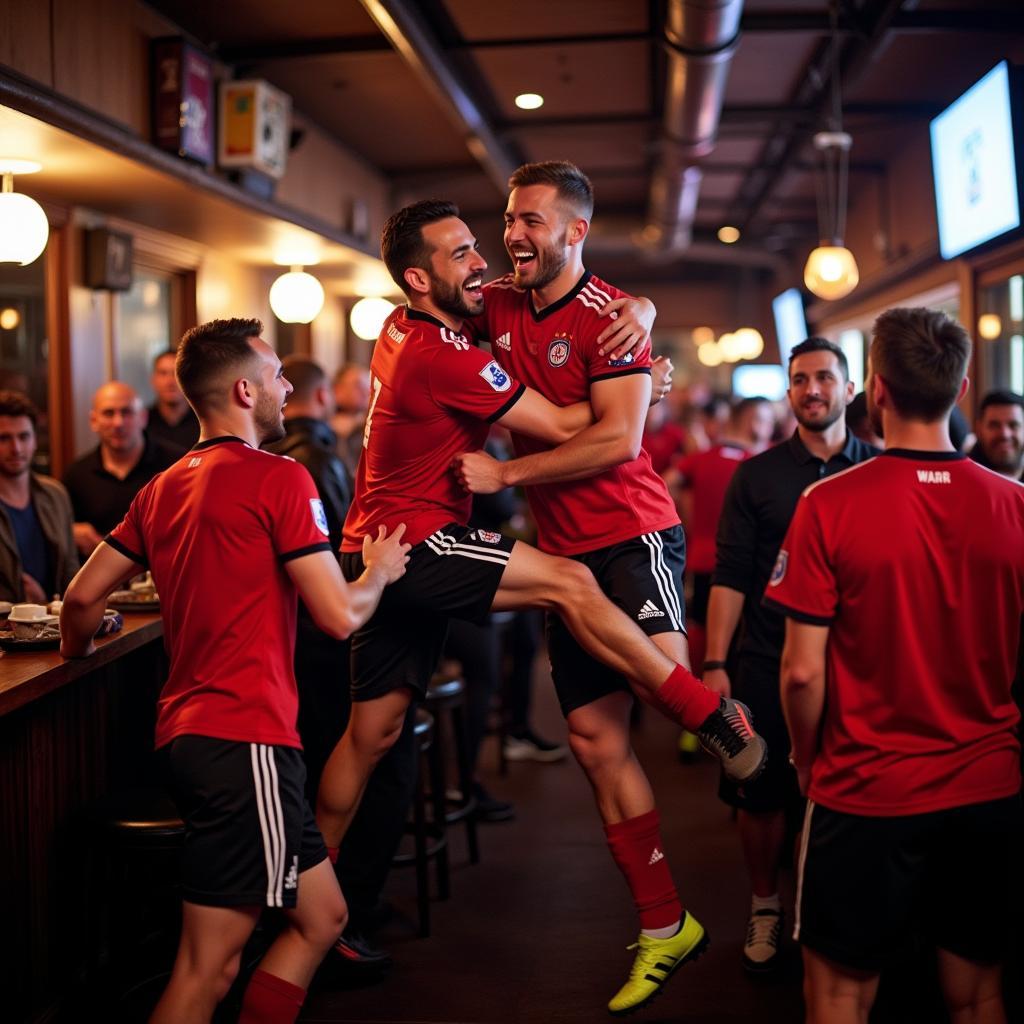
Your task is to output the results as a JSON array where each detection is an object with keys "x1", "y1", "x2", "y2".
[{"x1": 63, "y1": 381, "x2": 181, "y2": 558}]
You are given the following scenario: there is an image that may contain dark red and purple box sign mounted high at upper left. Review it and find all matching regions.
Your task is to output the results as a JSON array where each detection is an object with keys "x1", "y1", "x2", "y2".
[{"x1": 153, "y1": 38, "x2": 214, "y2": 164}]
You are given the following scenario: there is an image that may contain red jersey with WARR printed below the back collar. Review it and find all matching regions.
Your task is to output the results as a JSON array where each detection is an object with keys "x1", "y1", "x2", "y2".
[{"x1": 765, "y1": 449, "x2": 1024, "y2": 817}]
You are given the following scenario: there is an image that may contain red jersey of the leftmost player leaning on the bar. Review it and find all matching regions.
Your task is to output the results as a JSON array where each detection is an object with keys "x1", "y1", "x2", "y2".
[{"x1": 106, "y1": 437, "x2": 331, "y2": 746}]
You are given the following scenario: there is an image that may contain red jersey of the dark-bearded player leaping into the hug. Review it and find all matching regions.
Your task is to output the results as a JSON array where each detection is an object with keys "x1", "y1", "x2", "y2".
[{"x1": 341, "y1": 306, "x2": 526, "y2": 551}]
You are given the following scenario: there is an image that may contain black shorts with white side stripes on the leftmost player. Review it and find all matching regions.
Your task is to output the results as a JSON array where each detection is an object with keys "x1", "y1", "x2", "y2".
[{"x1": 159, "y1": 735, "x2": 327, "y2": 907}]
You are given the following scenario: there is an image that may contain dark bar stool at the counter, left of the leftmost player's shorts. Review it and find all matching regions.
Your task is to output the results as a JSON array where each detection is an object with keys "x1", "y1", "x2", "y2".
[{"x1": 90, "y1": 790, "x2": 185, "y2": 988}]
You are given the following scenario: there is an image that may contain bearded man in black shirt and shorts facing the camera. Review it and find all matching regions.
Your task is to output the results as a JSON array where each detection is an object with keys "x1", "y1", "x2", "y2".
[{"x1": 703, "y1": 338, "x2": 878, "y2": 972}]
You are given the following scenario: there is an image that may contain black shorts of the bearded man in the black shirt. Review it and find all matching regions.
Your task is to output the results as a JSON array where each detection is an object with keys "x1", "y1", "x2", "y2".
[{"x1": 718, "y1": 654, "x2": 804, "y2": 821}]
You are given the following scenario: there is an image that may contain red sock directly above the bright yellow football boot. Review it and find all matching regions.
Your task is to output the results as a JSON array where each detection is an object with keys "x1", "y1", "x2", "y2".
[{"x1": 604, "y1": 811, "x2": 683, "y2": 928}]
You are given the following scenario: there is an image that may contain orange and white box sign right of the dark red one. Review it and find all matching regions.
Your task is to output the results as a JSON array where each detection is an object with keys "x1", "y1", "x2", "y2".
[{"x1": 217, "y1": 79, "x2": 292, "y2": 178}]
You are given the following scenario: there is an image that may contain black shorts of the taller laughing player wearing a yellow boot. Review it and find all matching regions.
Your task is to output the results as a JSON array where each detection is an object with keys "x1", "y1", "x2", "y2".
[{"x1": 547, "y1": 526, "x2": 686, "y2": 716}]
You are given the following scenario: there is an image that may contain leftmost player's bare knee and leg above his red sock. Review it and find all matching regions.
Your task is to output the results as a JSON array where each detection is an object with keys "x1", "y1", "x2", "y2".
[{"x1": 259, "y1": 860, "x2": 348, "y2": 988}]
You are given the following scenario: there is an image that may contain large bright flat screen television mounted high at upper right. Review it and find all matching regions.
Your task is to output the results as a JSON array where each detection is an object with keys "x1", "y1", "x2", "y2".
[{"x1": 931, "y1": 60, "x2": 1021, "y2": 259}]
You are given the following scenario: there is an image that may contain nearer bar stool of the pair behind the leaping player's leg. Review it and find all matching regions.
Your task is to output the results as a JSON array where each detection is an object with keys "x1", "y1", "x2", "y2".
[{"x1": 391, "y1": 708, "x2": 450, "y2": 938}]
